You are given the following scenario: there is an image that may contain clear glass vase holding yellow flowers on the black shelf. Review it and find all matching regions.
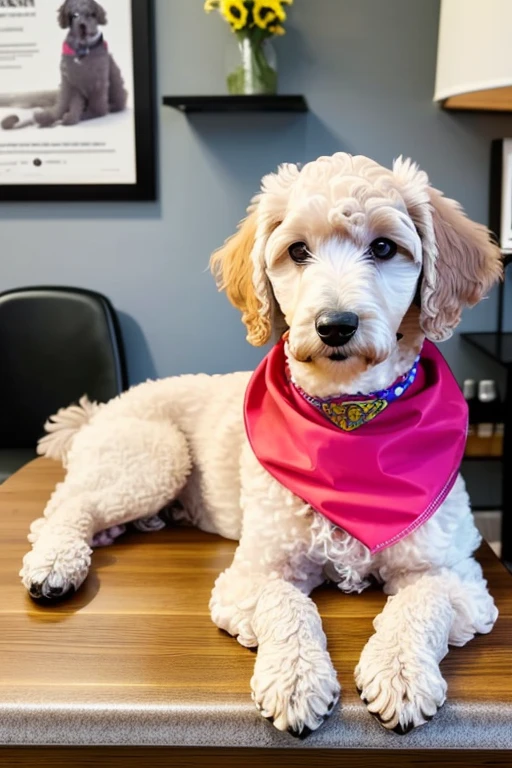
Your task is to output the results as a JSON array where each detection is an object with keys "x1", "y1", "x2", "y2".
[{"x1": 227, "y1": 35, "x2": 277, "y2": 96}]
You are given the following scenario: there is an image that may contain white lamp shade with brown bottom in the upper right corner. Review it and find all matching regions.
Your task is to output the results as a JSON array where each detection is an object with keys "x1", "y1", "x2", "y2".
[{"x1": 434, "y1": 0, "x2": 512, "y2": 109}]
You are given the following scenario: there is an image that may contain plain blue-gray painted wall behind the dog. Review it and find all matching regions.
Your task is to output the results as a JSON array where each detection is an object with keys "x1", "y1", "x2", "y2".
[{"x1": 0, "y1": 0, "x2": 512, "y2": 381}]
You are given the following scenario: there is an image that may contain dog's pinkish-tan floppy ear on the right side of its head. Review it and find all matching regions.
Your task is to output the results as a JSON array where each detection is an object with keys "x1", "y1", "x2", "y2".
[{"x1": 393, "y1": 158, "x2": 503, "y2": 341}]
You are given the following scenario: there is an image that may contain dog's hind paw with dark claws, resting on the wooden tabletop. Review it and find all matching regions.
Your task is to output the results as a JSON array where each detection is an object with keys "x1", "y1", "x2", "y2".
[{"x1": 20, "y1": 537, "x2": 92, "y2": 600}]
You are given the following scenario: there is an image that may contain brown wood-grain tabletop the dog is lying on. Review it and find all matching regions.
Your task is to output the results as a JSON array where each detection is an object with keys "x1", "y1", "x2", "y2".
[{"x1": 0, "y1": 459, "x2": 512, "y2": 768}]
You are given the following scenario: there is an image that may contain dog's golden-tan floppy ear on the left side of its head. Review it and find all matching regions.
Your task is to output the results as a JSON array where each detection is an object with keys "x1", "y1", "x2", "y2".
[{"x1": 210, "y1": 164, "x2": 299, "y2": 347}]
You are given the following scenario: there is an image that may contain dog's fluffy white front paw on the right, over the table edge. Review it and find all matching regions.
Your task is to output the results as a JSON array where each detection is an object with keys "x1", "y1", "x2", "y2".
[{"x1": 355, "y1": 632, "x2": 447, "y2": 734}]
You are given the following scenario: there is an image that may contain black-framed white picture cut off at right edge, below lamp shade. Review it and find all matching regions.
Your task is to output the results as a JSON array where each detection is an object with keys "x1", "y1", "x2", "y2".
[{"x1": 489, "y1": 139, "x2": 512, "y2": 253}]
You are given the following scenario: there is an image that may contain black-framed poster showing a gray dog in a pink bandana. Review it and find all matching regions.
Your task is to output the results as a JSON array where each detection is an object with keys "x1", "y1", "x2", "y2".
[{"x1": 0, "y1": 0, "x2": 156, "y2": 201}]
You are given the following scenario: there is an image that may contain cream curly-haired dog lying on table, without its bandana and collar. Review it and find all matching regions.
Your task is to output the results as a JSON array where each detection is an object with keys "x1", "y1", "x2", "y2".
[{"x1": 21, "y1": 153, "x2": 501, "y2": 735}]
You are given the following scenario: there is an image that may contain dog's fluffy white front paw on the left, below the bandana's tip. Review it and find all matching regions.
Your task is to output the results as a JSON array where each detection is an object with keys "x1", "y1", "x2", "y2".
[{"x1": 251, "y1": 644, "x2": 340, "y2": 738}]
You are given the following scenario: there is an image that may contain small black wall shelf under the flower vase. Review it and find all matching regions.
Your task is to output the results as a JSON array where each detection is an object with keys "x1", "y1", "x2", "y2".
[{"x1": 163, "y1": 95, "x2": 309, "y2": 113}]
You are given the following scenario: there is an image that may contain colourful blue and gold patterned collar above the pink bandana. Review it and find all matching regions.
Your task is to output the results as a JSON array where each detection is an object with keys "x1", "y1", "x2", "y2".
[{"x1": 292, "y1": 355, "x2": 420, "y2": 432}]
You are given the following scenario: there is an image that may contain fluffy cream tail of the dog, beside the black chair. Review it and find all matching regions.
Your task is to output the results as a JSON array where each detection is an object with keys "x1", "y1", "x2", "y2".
[{"x1": 37, "y1": 395, "x2": 101, "y2": 465}]
